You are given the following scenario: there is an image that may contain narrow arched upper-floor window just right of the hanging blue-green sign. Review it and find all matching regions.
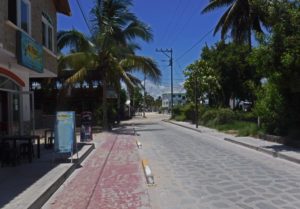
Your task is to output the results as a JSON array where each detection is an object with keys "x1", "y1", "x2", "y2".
[{"x1": 42, "y1": 13, "x2": 54, "y2": 51}]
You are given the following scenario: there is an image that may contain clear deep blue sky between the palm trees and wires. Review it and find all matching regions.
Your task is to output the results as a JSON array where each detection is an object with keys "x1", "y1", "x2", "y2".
[{"x1": 58, "y1": 0, "x2": 225, "y2": 97}]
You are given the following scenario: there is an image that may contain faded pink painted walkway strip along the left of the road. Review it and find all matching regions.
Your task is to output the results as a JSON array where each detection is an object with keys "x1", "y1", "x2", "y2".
[{"x1": 43, "y1": 135, "x2": 151, "y2": 209}]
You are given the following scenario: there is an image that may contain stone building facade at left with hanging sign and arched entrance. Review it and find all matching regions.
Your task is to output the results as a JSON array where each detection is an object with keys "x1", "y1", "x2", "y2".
[{"x1": 0, "y1": 0, "x2": 71, "y2": 135}]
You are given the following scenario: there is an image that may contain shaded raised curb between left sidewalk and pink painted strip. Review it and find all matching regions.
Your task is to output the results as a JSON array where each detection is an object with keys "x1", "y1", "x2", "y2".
[{"x1": 28, "y1": 144, "x2": 95, "y2": 209}]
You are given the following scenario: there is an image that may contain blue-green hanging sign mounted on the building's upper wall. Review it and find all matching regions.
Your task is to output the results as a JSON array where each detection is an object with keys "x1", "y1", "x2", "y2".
[{"x1": 17, "y1": 31, "x2": 44, "y2": 73}]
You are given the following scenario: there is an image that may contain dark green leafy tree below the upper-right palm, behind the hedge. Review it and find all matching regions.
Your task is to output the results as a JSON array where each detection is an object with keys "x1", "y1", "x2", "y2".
[{"x1": 201, "y1": 41, "x2": 260, "y2": 107}]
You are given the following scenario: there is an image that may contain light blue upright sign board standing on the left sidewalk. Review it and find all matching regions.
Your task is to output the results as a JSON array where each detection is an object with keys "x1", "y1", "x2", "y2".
[{"x1": 54, "y1": 112, "x2": 76, "y2": 152}]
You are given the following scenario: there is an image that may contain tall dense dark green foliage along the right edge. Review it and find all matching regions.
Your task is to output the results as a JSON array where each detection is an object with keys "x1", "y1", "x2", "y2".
[{"x1": 249, "y1": 0, "x2": 300, "y2": 135}]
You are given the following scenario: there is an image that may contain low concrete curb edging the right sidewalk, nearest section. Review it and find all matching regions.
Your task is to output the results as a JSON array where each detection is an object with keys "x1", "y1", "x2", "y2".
[{"x1": 224, "y1": 138, "x2": 300, "y2": 164}]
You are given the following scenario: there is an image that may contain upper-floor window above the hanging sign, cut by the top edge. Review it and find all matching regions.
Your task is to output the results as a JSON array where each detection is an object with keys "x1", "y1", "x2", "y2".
[{"x1": 8, "y1": 0, "x2": 31, "y2": 34}]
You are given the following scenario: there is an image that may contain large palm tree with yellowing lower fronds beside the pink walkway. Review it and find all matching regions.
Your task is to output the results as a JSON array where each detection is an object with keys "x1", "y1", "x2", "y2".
[{"x1": 58, "y1": 0, "x2": 160, "y2": 130}]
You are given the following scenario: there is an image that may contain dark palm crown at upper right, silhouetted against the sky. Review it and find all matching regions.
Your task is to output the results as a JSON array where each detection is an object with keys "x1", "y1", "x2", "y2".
[{"x1": 202, "y1": 0, "x2": 266, "y2": 50}]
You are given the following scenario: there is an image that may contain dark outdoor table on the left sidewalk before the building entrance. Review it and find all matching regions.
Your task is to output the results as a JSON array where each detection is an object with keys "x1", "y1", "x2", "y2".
[{"x1": 1, "y1": 135, "x2": 40, "y2": 162}]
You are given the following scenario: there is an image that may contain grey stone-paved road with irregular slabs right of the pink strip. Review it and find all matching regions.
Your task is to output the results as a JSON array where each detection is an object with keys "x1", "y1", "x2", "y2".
[{"x1": 134, "y1": 115, "x2": 300, "y2": 209}]
